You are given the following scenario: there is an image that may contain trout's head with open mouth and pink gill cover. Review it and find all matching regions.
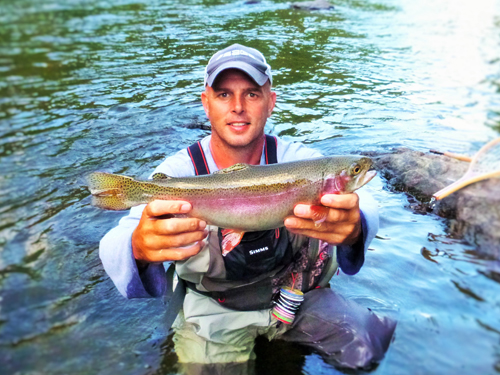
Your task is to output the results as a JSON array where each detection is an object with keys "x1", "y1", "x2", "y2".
[{"x1": 322, "y1": 156, "x2": 377, "y2": 194}]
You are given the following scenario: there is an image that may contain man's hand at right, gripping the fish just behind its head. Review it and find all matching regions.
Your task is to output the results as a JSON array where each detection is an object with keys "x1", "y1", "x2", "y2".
[{"x1": 285, "y1": 193, "x2": 361, "y2": 245}]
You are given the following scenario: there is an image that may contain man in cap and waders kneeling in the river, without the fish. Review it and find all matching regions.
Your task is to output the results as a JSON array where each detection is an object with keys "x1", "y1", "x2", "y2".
[{"x1": 100, "y1": 44, "x2": 395, "y2": 371}]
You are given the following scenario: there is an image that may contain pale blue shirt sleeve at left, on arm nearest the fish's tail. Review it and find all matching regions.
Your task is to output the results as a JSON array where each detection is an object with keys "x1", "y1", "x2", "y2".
[{"x1": 99, "y1": 150, "x2": 193, "y2": 298}]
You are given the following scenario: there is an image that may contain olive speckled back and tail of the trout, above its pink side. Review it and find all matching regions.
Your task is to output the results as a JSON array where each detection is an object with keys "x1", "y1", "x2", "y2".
[{"x1": 87, "y1": 155, "x2": 371, "y2": 210}]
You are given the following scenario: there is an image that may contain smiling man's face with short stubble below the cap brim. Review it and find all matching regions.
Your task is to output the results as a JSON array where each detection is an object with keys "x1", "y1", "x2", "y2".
[{"x1": 201, "y1": 69, "x2": 276, "y2": 148}]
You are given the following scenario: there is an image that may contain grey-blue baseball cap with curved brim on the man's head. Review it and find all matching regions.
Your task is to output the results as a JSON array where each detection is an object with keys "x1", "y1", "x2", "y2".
[{"x1": 205, "y1": 44, "x2": 273, "y2": 87}]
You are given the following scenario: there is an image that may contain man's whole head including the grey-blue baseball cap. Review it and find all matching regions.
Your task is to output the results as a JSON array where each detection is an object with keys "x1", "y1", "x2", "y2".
[{"x1": 201, "y1": 44, "x2": 276, "y2": 150}]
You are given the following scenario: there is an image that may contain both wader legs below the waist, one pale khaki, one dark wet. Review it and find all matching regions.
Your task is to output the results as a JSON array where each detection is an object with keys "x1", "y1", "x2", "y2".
[{"x1": 174, "y1": 288, "x2": 396, "y2": 374}]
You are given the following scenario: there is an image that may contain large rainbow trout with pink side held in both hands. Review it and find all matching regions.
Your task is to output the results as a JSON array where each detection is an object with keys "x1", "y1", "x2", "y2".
[{"x1": 87, "y1": 155, "x2": 376, "y2": 251}]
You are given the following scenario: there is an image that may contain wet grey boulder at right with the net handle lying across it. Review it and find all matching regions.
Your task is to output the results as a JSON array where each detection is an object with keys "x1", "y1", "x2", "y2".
[{"x1": 370, "y1": 149, "x2": 500, "y2": 259}]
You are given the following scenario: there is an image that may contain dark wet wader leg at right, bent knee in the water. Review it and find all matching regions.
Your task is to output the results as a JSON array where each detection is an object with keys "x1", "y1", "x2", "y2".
[{"x1": 281, "y1": 288, "x2": 396, "y2": 368}]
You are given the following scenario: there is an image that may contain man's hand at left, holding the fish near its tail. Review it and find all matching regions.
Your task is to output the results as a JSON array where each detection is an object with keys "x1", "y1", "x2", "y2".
[{"x1": 132, "y1": 200, "x2": 208, "y2": 264}]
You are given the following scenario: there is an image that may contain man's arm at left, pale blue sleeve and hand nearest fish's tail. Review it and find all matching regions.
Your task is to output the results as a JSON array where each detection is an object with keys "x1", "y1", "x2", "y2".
[{"x1": 99, "y1": 150, "x2": 204, "y2": 298}]
